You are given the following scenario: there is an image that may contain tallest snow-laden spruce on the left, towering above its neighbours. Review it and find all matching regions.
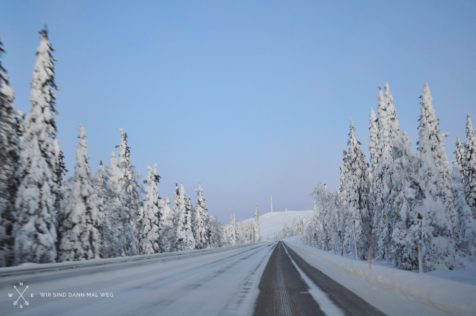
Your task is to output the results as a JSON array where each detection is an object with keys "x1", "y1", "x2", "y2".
[{"x1": 14, "y1": 29, "x2": 57, "y2": 264}]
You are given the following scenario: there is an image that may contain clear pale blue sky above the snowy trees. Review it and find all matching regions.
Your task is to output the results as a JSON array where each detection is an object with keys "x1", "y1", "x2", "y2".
[{"x1": 0, "y1": 0, "x2": 476, "y2": 222}]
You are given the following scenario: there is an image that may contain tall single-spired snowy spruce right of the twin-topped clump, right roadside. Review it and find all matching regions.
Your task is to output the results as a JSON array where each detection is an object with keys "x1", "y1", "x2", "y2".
[{"x1": 418, "y1": 84, "x2": 458, "y2": 270}]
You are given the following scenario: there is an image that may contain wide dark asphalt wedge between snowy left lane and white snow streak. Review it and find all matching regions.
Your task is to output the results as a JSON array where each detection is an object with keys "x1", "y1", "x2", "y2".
[{"x1": 254, "y1": 242, "x2": 324, "y2": 316}]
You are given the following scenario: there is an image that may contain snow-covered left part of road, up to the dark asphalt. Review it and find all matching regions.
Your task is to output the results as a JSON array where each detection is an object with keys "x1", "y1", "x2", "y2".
[{"x1": 0, "y1": 243, "x2": 275, "y2": 315}]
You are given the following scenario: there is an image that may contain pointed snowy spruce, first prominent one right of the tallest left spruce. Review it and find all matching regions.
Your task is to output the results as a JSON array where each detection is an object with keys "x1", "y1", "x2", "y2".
[{"x1": 59, "y1": 126, "x2": 101, "y2": 261}]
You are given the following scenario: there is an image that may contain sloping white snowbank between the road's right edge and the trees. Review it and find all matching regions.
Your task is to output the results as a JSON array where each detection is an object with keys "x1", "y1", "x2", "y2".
[{"x1": 286, "y1": 238, "x2": 476, "y2": 315}]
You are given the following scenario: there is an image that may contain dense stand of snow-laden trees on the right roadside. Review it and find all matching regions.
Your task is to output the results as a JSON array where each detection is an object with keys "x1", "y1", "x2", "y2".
[{"x1": 283, "y1": 84, "x2": 476, "y2": 271}]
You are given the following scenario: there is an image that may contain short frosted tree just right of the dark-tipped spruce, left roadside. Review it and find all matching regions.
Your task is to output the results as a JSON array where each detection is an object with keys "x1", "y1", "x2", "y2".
[{"x1": 159, "y1": 198, "x2": 176, "y2": 252}]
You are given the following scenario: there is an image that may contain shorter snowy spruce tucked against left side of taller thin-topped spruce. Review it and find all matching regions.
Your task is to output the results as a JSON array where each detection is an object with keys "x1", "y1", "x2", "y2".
[{"x1": 102, "y1": 151, "x2": 132, "y2": 258}]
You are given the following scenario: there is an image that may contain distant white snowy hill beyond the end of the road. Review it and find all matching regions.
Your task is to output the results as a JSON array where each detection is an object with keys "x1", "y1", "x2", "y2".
[{"x1": 245, "y1": 210, "x2": 312, "y2": 239}]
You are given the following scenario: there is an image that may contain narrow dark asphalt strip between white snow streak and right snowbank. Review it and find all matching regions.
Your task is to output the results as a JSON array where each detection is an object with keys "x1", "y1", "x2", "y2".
[{"x1": 286, "y1": 242, "x2": 385, "y2": 316}]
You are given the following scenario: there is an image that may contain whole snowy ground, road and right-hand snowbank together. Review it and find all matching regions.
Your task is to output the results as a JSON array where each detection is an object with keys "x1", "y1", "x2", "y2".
[{"x1": 0, "y1": 240, "x2": 470, "y2": 316}]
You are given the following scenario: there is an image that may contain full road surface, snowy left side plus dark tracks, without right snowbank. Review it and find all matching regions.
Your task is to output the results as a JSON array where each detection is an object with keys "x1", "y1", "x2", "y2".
[{"x1": 0, "y1": 242, "x2": 404, "y2": 315}]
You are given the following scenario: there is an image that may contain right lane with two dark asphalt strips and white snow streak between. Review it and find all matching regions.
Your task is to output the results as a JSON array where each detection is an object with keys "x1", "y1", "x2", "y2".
[{"x1": 254, "y1": 242, "x2": 384, "y2": 315}]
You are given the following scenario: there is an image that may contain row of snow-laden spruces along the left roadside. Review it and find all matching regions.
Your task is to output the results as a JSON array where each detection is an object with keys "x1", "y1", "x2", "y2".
[{"x1": 0, "y1": 29, "x2": 231, "y2": 266}]
